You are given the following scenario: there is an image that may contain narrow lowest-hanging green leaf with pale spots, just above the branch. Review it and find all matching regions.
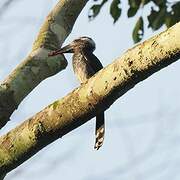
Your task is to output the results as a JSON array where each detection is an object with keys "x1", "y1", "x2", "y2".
[{"x1": 132, "y1": 16, "x2": 144, "y2": 43}]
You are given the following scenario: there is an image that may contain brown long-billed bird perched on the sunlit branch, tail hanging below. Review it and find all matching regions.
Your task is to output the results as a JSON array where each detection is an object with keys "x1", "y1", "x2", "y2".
[{"x1": 49, "y1": 36, "x2": 105, "y2": 150}]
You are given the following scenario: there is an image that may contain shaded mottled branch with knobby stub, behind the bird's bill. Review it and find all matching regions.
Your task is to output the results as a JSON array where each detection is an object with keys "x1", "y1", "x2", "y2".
[{"x1": 0, "y1": 0, "x2": 88, "y2": 128}]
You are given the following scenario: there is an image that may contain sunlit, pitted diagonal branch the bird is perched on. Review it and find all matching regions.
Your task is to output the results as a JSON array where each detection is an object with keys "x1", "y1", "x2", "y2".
[{"x1": 0, "y1": 23, "x2": 180, "y2": 176}]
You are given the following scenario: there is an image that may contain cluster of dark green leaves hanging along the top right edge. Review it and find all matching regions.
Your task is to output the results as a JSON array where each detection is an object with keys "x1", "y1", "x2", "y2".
[{"x1": 89, "y1": 0, "x2": 180, "y2": 43}]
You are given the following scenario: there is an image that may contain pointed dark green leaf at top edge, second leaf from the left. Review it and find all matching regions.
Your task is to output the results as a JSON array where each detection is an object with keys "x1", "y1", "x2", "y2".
[{"x1": 110, "y1": 0, "x2": 121, "y2": 23}]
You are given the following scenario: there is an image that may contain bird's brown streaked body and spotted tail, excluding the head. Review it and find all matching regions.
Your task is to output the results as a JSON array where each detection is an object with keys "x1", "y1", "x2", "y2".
[{"x1": 72, "y1": 38, "x2": 105, "y2": 150}]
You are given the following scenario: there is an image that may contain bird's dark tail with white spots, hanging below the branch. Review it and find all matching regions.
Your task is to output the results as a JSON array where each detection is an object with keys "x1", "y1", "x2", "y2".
[{"x1": 94, "y1": 112, "x2": 105, "y2": 150}]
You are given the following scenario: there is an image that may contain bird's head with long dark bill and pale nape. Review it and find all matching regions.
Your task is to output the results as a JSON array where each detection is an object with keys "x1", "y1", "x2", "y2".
[{"x1": 49, "y1": 36, "x2": 96, "y2": 56}]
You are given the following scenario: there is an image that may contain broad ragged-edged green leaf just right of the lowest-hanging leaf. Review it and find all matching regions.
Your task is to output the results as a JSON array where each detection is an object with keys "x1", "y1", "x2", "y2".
[{"x1": 148, "y1": 7, "x2": 167, "y2": 30}]
